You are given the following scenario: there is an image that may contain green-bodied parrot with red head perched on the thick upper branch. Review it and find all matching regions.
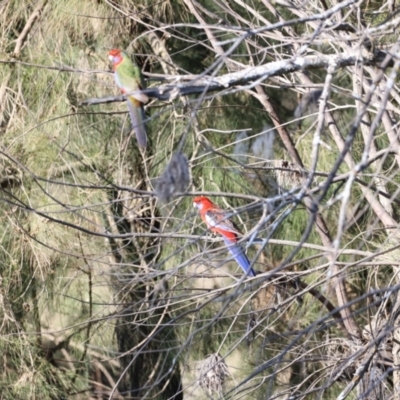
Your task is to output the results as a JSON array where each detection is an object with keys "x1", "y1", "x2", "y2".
[{"x1": 108, "y1": 49, "x2": 149, "y2": 148}]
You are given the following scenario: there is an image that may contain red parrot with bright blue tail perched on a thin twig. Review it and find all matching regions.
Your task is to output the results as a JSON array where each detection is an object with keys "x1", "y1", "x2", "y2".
[{"x1": 193, "y1": 196, "x2": 256, "y2": 277}]
